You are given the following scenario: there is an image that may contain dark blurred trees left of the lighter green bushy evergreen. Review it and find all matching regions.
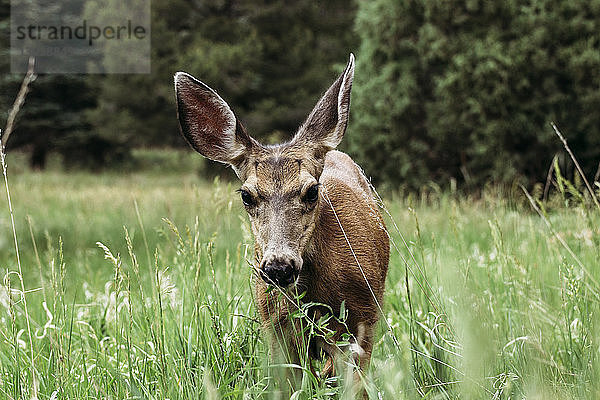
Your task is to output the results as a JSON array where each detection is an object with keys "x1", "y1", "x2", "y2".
[{"x1": 0, "y1": 0, "x2": 356, "y2": 167}]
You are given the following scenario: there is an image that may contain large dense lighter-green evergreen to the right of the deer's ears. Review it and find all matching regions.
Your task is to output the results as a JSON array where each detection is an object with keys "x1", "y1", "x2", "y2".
[{"x1": 349, "y1": 0, "x2": 600, "y2": 188}]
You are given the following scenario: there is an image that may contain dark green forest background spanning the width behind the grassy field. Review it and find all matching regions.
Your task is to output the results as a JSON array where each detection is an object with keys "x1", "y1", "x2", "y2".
[{"x1": 0, "y1": 0, "x2": 600, "y2": 190}]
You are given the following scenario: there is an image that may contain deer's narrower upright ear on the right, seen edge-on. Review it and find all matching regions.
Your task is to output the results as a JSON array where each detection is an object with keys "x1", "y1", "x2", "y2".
[{"x1": 293, "y1": 53, "x2": 354, "y2": 152}]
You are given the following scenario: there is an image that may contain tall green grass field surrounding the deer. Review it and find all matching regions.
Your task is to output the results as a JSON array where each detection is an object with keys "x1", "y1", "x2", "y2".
[{"x1": 0, "y1": 151, "x2": 600, "y2": 399}]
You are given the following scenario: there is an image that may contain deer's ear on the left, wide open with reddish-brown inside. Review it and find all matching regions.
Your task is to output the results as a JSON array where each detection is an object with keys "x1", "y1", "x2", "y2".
[{"x1": 175, "y1": 72, "x2": 255, "y2": 169}]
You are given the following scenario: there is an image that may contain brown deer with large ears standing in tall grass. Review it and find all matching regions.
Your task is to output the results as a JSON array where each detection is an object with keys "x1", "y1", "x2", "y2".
[{"x1": 174, "y1": 54, "x2": 390, "y2": 394}]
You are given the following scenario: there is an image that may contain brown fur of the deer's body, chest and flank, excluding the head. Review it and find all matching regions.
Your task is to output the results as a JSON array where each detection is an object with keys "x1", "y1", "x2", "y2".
[{"x1": 256, "y1": 151, "x2": 389, "y2": 374}]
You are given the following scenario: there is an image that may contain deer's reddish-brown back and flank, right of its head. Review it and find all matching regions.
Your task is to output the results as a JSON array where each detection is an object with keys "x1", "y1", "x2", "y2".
[{"x1": 307, "y1": 151, "x2": 389, "y2": 325}]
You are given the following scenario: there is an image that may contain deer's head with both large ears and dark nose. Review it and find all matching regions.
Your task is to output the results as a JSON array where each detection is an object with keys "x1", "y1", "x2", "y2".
[{"x1": 175, "y1": 54, "x2": 354, "y2": 287}]
